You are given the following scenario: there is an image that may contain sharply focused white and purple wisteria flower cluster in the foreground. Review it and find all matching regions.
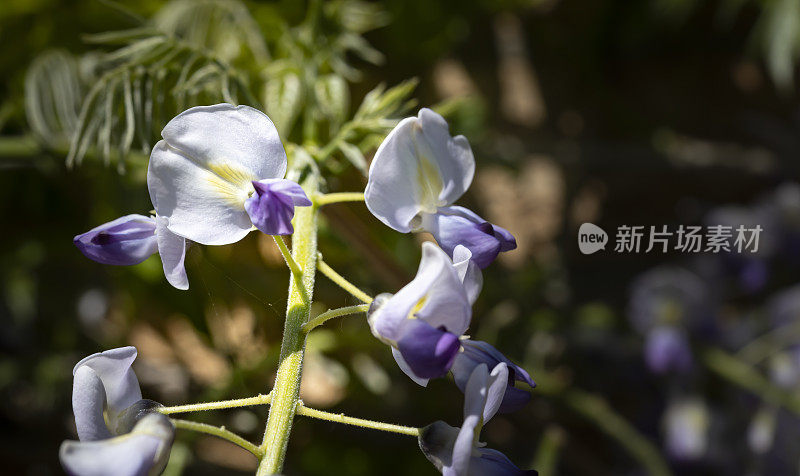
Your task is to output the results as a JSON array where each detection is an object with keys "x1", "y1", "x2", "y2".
[{"x1": 61, "y1": 104, "x2": 535, "y2": 476}]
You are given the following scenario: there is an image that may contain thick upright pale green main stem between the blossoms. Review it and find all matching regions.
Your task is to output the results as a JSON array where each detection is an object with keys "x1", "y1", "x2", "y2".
[{"x1": 256, "y1": 174, "x2": 318, "y2": 476}]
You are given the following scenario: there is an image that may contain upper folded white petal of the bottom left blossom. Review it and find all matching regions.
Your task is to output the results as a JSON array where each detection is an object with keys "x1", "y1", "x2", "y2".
[{"x1": 72, "y1": 347, "x2": 142, "y2": 420}]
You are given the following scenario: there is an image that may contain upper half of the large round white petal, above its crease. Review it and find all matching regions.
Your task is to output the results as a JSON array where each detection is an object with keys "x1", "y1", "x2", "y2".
[{"x1": 161, "y1": 104, "x2": 286, "y2": 180}]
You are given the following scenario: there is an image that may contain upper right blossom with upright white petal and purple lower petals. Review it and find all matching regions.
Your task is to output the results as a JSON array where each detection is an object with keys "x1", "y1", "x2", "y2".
[{"x1": 364, "y1": 108, "x2": 517, "y2": 268}]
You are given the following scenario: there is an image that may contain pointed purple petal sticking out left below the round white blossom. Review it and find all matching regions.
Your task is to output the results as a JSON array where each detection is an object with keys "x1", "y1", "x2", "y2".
[{"x1": 73, "y1": 215, "x2": 158, "y2": 266}]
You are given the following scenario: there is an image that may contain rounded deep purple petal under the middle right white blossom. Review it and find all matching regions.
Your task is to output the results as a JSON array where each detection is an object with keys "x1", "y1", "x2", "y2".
[{"x1": 397, "y1": 319, "x2": 461, "y2": 379}]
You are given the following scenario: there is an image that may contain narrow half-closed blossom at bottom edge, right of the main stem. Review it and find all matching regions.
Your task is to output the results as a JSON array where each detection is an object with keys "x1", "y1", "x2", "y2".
[{"x1": 419, "y1": 363, "x2": 537, "y2": 476}]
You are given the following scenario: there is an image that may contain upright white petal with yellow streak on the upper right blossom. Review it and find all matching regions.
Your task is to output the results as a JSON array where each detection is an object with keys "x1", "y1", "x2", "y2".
[{"x1": 364, "y1": 109, "x2": 475, "y2": 233}]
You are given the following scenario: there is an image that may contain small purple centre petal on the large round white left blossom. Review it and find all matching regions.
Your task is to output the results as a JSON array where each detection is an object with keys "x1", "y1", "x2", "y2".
[{"x1": 244, "y1": 179, "x2": 311, "y2": 235}]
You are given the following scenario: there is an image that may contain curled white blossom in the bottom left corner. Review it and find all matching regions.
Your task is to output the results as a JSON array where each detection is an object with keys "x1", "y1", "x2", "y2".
[{"x1": 60, "y1": 347, "x2": 175, "y2": 476}]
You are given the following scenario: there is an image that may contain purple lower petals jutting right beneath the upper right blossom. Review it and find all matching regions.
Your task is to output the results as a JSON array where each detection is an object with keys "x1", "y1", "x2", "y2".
[{"x1": 422, "y1": 206, "x2": 517, "y2": 269}]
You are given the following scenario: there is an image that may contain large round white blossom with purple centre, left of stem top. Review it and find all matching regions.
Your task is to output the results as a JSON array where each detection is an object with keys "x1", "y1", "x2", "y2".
[{"x1": 147, "y1": 104, "x2": 311, "y2": 245}]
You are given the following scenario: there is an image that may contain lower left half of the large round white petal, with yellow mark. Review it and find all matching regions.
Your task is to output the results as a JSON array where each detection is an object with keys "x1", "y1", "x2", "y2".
[{"x1": 147, "y1": 141, "x2": 253, "y2": 245}]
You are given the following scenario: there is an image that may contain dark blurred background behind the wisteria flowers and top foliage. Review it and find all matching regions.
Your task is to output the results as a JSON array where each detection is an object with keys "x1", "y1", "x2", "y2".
[{"x1": 0, "y1": 0, "x2": 800, "y2": 475}]
